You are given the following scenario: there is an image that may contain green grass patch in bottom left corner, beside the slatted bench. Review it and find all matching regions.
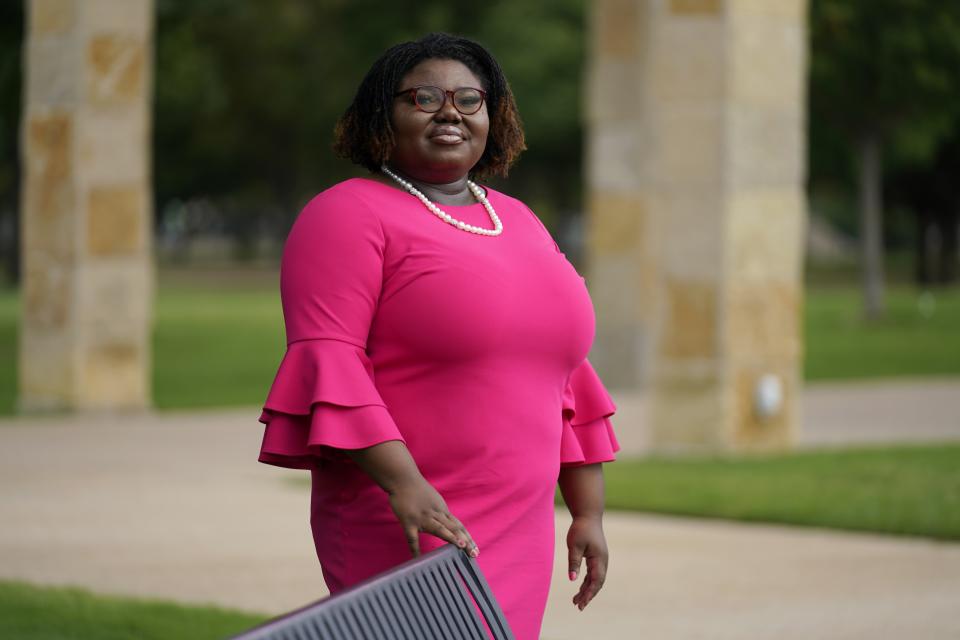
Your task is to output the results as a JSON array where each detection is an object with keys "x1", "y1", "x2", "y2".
[{"x1": 0, "y1": 581, "x2": 267, "y2": 640}]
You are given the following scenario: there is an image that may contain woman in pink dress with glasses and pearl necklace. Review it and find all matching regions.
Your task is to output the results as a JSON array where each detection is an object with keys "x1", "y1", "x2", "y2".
[{"x1": 260, "y1": 34, "x2": 618, "y2": 639}]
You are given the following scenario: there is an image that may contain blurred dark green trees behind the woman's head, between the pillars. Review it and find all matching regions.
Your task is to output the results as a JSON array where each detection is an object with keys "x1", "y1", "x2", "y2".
[{"x1": 154, "y1": 0, "x2": 584, "y2": 255}]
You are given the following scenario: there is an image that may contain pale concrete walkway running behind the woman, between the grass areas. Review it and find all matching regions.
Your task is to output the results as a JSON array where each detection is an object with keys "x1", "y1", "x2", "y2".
[{"x1": 0, "y1": 382, "x2": 960, "y2": 640}]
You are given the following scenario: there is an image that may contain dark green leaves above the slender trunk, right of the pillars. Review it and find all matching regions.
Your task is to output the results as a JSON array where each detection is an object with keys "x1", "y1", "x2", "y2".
[{"x1": 808, "y1": 0, "x2": 960, "y2": 202}]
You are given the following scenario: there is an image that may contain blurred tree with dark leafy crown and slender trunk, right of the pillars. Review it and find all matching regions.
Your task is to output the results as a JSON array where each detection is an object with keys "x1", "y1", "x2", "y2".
[{"x1": 810, "y1": 0, "x2": 960, "y2": 318}]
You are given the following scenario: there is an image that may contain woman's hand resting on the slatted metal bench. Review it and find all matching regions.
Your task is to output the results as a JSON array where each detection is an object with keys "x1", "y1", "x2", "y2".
[{"x1": 389, "y1": 476, "x2": 480, "y2": 558}]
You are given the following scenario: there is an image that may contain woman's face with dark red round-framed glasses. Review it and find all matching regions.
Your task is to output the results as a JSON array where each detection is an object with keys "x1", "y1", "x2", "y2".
[{"x1": 389, "y1": 59, "x2": 490, "y2": 184}]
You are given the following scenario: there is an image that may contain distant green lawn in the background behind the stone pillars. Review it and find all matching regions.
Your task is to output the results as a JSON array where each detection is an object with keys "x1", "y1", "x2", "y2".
[{"x1": 0, "y1": 271, "x2": 960, "y2": 415}]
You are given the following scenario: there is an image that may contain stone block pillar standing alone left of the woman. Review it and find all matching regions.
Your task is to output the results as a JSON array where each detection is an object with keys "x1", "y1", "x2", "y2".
[{"x1": 19, "y1": 0, "x2": 153, "y2": 411}]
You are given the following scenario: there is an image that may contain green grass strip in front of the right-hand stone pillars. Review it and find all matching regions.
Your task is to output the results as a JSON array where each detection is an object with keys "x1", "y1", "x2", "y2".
[{"x1": 605, "y1": 443, "x2": 960, "y2": 540}]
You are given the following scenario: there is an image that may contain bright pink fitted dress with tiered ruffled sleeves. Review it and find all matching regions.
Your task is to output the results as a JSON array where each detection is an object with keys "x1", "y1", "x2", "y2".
[{"x1": 260, "y1": 178, "x2": 619, "y2": 640}]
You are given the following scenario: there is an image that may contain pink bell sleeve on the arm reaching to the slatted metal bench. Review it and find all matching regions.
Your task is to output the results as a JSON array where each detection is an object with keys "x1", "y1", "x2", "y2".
[{"x1": 259, "y1": 189, "x2": 403, "y2": 469}]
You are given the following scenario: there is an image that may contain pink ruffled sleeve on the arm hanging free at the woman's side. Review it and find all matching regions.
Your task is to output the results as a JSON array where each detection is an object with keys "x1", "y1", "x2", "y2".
[{"x1": 560, "y1": 360, "x2": 620, "y2": 466}]
